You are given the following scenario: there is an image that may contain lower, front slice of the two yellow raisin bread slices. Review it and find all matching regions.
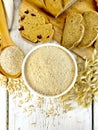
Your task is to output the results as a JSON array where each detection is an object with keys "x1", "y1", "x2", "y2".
[{"x1": 20, "y1": 24, "x2": 53, "y2": 43}]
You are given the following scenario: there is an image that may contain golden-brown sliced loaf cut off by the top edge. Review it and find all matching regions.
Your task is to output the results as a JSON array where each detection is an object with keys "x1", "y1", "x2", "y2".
[{"x1": 27, "y1": 0, "x2": 77, "y2": 17}]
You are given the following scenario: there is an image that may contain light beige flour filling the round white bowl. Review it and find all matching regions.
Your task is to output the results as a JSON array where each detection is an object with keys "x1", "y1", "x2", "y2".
[{"x1": 25, "y1": 46, "x2": 75, "y2": 96}]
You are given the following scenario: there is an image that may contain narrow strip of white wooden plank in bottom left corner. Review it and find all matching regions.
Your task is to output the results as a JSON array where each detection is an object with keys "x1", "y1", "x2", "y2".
[{"x1": 0, "y1": 87, "x2": 7, "y2": 130}]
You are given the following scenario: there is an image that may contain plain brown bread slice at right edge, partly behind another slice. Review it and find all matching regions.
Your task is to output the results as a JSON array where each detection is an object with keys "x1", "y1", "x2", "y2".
[{"x1": 78, "y1": 11, "x2": 98, "y2": 48}]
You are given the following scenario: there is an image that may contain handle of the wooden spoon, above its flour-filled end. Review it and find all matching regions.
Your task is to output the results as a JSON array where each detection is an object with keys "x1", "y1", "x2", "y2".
[{"x1": 0, "y1": 0, "x2": 14, "y2": 50}]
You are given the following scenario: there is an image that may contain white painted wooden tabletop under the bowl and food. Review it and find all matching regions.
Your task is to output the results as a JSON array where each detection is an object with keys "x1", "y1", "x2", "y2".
[{"x1": 0, "y1": 0, "x2": 98, "y2": 130}]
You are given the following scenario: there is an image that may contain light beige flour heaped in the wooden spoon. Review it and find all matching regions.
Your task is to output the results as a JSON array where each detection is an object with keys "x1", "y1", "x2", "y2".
[{"x1": 0, "y1": 46, "x2": 24, "y2": 75}]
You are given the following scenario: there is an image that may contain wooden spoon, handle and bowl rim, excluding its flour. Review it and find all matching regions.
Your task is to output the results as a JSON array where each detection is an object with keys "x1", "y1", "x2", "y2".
[{"x1": 0, "y1": 0, "x2": 21, "y2": 78}]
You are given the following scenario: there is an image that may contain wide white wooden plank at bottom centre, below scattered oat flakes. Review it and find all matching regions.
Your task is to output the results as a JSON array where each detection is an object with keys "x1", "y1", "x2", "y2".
[{"x1": 9, "y1": 97, "x2": 92, "y2": 130}]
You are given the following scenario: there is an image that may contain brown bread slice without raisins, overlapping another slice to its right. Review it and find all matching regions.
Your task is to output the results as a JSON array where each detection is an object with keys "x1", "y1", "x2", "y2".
[{"x1": 62, "y1": 12, "x2": 84, "y2": 49}]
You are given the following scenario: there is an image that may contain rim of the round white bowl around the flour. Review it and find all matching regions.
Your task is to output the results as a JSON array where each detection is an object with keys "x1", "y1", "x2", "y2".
[{"x1": 22, "y1": 43, "x2": 78, "y2": 98}]
